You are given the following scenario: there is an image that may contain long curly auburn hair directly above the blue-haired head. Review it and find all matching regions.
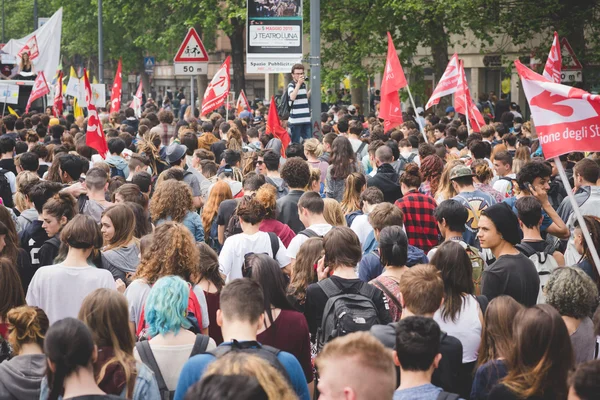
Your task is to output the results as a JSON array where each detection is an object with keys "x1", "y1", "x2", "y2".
[{"x1": 134, "y1": 222, "x2": 200, "y2": 285}]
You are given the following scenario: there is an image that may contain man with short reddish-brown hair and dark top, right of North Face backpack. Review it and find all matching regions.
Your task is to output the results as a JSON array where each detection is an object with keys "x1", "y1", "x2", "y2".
[{"x1": 371, "y1": 264, "x2": 462, "y2": 392}]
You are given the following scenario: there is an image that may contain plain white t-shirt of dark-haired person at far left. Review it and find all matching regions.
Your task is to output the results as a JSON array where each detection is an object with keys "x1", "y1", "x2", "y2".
[{"x1": 26, "y1": 264, "x2": 116, "y2": 325}]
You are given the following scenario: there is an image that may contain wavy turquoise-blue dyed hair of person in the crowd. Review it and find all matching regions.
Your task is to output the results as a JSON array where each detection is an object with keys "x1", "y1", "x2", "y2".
[{"x1": 144, "y1": 276, "x2": 191, "y2": 336}]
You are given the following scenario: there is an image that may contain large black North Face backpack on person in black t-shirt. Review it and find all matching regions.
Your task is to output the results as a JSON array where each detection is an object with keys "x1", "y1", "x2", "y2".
[{"x1": 317, "y1": 279, "x2": 380, "y2": 351}]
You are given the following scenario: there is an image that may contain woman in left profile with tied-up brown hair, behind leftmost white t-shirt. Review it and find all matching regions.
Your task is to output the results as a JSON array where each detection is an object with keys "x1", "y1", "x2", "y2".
[{"x1": 38, "y1": 192, "x2": 77, "y2": 267}]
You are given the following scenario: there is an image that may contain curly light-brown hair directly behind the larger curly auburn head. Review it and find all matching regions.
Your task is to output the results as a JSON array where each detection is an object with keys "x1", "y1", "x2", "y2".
[{"x1": 150, "y1": 179, "x2": 194, "y2": 222}]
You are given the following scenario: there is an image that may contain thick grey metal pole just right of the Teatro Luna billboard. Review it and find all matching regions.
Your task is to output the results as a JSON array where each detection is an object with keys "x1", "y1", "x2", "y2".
[{"x1": 309, "y1": 0, "x2": 321, "y2": 141}]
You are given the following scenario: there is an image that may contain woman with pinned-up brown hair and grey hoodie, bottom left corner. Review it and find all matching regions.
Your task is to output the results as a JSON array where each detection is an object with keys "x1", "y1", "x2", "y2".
[{"x1": 0, "y1": 306, "x2": 50, "y2": 399}]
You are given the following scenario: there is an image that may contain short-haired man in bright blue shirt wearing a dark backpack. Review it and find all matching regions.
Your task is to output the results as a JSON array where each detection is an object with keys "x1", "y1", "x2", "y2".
[{"x1": 175, "y1": 278, "x2": 310, "y2": 400}]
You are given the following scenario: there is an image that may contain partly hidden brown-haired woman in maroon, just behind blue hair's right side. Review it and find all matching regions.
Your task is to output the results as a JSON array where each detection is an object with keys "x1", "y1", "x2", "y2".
[{"x1": 192, "y1": 243, "x2": 225, "y2": 345}]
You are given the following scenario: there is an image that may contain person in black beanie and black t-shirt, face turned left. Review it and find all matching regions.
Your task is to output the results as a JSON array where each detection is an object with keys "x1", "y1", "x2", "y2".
[{"x1": 477, "y1": 203, "x2": 540, "y2": 307}]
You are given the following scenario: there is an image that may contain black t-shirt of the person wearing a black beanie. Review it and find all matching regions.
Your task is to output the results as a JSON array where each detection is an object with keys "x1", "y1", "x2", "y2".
[{"x1": 481, "y1": 253, "x2": 540, "y2": 307}]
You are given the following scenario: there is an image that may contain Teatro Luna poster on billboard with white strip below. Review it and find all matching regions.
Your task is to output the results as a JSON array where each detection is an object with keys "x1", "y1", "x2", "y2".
[{"x1": 246, "y1": 0, "x2": 302, "y2": 74}]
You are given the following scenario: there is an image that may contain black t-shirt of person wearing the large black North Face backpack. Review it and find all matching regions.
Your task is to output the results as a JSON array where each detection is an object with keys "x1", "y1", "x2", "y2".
[{"x1": 304, "y1": 276, "x2": 394, "y2": 340}]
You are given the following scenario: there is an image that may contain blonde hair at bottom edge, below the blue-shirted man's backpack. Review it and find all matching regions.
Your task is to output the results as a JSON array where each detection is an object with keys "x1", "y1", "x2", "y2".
[{"x1": 204, "y1": 352, "x2": 298, "y2": 400}]
